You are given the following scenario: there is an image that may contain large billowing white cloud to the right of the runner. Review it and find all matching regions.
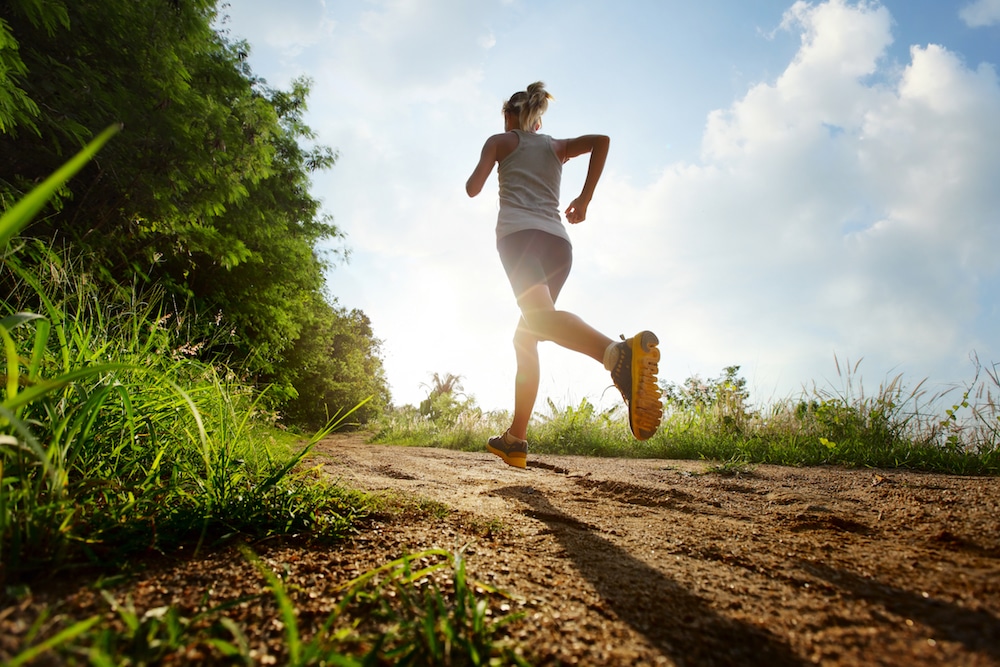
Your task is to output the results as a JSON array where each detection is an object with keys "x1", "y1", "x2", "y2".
[{"x1": 568, "y1": 0, "x2": 1000, "y2": 408}]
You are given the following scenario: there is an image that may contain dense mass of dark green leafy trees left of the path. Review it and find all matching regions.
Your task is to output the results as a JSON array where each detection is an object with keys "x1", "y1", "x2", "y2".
[{"x1": 0, "y1": 0, "x2": 389, "y2": 427}]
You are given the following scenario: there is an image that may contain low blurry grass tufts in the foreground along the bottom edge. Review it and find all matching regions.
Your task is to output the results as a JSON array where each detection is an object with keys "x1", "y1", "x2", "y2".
[{"x1": 6, "y1": 548, "x2": 525, "y2": 667}]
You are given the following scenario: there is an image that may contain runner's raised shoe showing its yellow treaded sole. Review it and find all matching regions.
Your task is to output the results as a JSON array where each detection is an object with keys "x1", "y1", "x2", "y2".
[{"x1": 611, "y1": 331, "x2": 663, "y2": 440}]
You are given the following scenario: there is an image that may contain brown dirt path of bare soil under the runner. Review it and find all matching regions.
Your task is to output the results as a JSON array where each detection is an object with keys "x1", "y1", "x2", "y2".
[{"x1": 0, "y1": 436, "x2": 1000, "y2": 666}]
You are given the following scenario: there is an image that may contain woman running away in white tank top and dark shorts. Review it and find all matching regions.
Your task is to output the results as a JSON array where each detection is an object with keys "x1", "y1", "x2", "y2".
[{"x1": 465, "y1": 81, "x2": 663, "y2": 468}]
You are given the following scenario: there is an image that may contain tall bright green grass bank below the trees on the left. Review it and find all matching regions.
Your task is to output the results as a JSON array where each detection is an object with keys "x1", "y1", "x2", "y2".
[{"x1": 0, "y1": 245, "x2": 374, "y2": 579}]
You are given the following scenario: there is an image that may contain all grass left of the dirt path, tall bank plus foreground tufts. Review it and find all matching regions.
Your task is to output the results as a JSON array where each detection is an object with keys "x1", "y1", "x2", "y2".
[{"x1": 0, "y1": 107, "x2": 520, "y2": 666}]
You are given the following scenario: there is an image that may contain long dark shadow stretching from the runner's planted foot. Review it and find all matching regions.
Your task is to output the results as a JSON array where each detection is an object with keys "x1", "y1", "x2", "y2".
[{"x1": 495, "y1": 486, "x2": 805, "y2": 667}]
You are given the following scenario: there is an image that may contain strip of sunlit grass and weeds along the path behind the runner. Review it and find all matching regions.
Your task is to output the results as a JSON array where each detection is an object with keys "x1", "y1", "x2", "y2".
[{"x1": 374, "y1": 360, "x2": 1000, "y2": 475}]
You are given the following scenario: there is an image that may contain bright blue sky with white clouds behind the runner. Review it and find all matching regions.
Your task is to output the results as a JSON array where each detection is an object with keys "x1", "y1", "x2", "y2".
[{"x1": 219, "y1": 0, "x2": 1000, "y2": 413}]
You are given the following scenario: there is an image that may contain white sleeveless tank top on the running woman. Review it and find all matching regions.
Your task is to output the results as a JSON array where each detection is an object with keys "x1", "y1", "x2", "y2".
[{"x1": 497, "y1": 130, "x2": 569, "y2": 241}]
